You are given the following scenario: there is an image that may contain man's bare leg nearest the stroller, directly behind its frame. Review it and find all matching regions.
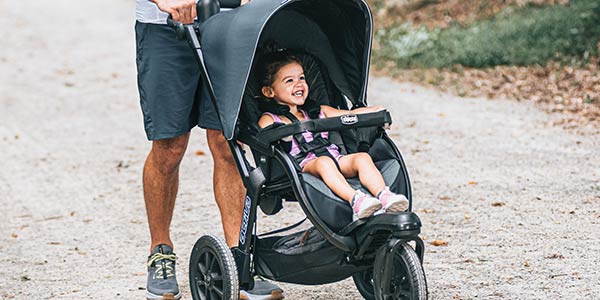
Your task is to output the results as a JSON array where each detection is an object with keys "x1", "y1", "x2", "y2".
[{"x1": 206, "y1": 129, "x2": 246, "y2": 248}]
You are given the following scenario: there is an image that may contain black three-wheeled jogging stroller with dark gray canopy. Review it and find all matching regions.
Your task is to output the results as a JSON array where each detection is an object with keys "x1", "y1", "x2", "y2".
[{"x1": 169, "y1": 0, "x2": 427, "y2": 299}]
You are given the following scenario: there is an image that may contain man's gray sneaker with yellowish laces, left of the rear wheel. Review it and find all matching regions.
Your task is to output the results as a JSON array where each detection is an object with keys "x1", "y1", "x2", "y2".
[{"x1": 146, "y1": 244, "x2": 181, "y2": 300}]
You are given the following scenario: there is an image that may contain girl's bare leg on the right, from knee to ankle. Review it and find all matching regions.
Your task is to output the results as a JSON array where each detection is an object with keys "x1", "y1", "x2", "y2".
[{"x1": 338, "y1": 152, "x2": 385, "y2": 196}]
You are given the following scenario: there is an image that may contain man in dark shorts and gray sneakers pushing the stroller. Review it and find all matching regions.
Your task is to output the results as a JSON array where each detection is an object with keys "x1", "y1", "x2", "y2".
[{"x1": 135, "y1": 0, "x2": 283, "y2": 300}]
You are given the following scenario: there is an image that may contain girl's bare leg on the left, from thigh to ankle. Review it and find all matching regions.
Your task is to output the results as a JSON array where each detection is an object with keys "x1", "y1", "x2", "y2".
[{"x1": 302, "y1": 156, "x2": 356, "y2": 204}]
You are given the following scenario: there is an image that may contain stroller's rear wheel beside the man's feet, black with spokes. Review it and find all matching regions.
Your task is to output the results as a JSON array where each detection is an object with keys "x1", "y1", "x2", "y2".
[{"x1": 190, "y1": 235, "x2": 240, "y2": 300}]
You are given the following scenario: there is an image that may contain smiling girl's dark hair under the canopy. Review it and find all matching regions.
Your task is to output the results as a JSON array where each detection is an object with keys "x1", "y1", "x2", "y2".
[{"x1": 256, "y1": 42, "x2": 302, "y2": 87}]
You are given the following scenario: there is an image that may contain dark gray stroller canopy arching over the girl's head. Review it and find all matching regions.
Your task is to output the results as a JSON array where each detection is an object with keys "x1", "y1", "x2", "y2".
[{"x1": 201, "y1": 0, "x2": 372, "y2": 139}]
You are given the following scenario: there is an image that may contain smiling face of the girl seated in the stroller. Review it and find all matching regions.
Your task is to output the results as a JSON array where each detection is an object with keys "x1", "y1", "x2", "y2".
[{"x1": 261, "y1": 62, "x2": 308, "y2": 106}]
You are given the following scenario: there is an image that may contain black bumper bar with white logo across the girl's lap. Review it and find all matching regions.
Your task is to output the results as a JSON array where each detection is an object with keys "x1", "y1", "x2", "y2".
[{"x1": 256, "y1": 110, "x2": 392, "y2": 144}]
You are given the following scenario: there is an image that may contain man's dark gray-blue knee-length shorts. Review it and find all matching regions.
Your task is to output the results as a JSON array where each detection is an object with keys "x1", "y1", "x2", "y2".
[{"x1": 135, "y1": 22, "x2": 221, "y2": 140}]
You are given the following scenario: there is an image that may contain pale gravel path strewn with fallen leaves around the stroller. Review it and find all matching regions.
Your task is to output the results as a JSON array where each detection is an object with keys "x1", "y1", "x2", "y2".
[{"x1": 0, "y1": 0, "x2": 600, "y2": 299}]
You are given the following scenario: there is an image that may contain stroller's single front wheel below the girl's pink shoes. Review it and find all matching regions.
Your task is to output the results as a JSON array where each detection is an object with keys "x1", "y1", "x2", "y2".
[{"x1": 373, "y1": 242, "x2": 428, "y2": 300}]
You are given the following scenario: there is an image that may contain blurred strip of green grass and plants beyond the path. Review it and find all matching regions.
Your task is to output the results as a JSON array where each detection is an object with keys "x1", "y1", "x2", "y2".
[{"x1": 375, "y1": 0, "x2": 600, "y2": 67}]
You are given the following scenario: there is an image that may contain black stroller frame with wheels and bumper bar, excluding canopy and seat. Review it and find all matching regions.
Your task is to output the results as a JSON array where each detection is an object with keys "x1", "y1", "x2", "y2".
[{"x1": 168, "y1": 0, "x2": 428, "y2": 299}]
